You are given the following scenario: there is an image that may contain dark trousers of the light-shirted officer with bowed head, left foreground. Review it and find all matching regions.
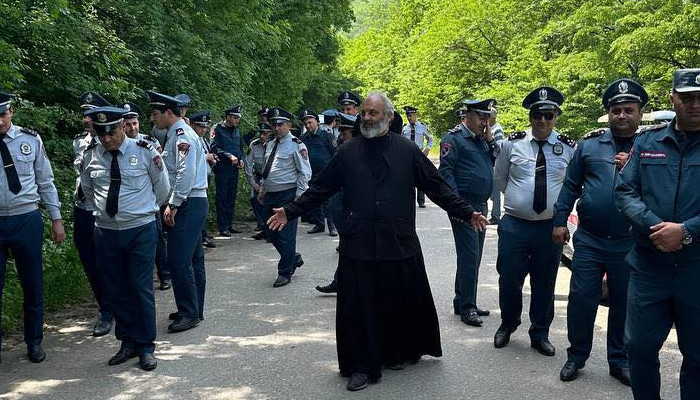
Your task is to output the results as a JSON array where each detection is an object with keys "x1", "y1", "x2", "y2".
[{"x1": 95, "y1": 222, "x2": 158, "y2": 354}]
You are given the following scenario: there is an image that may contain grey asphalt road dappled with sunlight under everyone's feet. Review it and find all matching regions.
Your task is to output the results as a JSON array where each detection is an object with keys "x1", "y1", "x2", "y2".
[{"x1": 0, "y1": 198, "x2": 680, "y2": 400}]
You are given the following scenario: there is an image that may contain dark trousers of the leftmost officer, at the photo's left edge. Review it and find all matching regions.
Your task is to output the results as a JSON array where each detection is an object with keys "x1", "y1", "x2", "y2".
[{"x1": 0, "y1": 210, "x2": 44, "y2": 345}]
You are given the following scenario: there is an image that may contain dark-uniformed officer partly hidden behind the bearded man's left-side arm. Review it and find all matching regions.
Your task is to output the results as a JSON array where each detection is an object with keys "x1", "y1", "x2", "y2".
[{"x1": 301, "y1": 109, "x2": 338, "y2": 236}]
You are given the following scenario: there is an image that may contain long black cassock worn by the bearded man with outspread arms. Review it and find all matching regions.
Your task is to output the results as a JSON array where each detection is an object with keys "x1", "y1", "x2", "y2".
[{"x1": 284, "y1": 135, "x2": 474, "y2": 380}]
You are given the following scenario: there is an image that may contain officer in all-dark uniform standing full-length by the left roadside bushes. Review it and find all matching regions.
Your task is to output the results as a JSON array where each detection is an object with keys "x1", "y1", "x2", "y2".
[{"x1": 211, "y1": 106, "x2": 245, "y2": 237}]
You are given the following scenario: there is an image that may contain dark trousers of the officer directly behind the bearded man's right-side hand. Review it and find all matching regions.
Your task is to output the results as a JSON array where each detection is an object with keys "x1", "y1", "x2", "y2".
[{"x1": 450, "y1": 203, "x2": 487, "y2": 315}]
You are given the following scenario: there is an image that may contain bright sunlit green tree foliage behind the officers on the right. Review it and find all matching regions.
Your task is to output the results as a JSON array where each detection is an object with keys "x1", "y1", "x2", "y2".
[{"x1": 340, "y1": 0, "x2": 700, "y2": 137}]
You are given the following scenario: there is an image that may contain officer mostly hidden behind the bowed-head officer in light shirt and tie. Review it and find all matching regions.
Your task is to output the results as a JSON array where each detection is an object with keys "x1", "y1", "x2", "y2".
[{"x1": 73, "y1": 92, "x2": 113, "y2": 337}]
